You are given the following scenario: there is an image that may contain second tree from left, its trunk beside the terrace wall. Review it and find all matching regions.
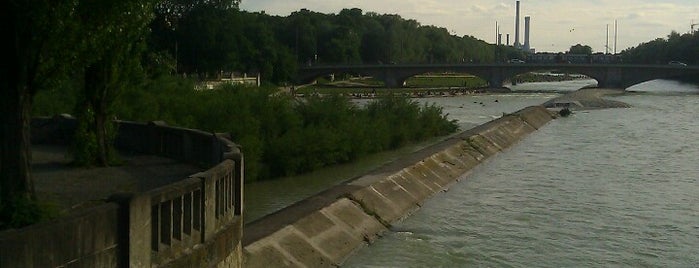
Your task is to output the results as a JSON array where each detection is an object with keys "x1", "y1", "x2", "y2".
[{"x1": 74, "y1": 0, "x2": 153, "y2": 166}]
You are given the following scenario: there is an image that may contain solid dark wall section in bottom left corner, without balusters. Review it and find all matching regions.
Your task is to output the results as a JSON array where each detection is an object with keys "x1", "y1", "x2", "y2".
[{"x1": 0, "y1": 203, "x2": 125, "y2": 267}]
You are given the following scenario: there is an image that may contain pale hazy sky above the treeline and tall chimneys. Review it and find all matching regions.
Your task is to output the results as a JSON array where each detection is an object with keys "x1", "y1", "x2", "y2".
[{"x1": 240, "y1": 0, "x2": 699, "y2": 52}]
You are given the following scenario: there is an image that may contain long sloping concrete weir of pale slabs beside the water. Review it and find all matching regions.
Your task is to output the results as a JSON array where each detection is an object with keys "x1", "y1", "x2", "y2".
[{"x1": 243, "y1": 106, "x2": 554, "y2": 267}]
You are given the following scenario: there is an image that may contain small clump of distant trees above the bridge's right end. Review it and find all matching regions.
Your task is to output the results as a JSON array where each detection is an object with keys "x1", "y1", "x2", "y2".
[{"x1": 621, "y1": 31, "x2": 699, "y2": 65}]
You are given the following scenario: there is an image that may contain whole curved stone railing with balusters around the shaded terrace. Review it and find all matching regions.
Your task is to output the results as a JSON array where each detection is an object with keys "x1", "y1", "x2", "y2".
[{"x1": 0, "y1": 115, "x2": 243, "y2": 267}]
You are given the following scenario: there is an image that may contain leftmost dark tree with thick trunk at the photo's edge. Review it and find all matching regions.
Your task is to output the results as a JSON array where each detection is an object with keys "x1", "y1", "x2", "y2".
[{"x1": 0, "y1": 0, "x2": 80, "y2": 226}]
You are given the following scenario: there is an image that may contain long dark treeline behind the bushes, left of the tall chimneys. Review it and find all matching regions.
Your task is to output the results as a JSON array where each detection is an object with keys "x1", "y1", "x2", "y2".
[{"x1": 150, "y1": 5, "x2": 522, "y2": 83}]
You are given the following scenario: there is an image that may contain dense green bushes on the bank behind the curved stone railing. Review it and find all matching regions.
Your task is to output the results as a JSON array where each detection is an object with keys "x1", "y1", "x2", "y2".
[{"x1": 35, "y1": 77, "x2": 457, "y2": 181}]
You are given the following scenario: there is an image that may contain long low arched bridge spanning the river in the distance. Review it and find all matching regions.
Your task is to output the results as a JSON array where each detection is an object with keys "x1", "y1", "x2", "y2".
[{"x1": 298, "y1": 63, "x2": 699, "y2": 88}]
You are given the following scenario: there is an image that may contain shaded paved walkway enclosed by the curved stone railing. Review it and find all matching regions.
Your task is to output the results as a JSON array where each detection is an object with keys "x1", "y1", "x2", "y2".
[{"x1": 32, "y1": 145, "x2": 203, "y2": 212}]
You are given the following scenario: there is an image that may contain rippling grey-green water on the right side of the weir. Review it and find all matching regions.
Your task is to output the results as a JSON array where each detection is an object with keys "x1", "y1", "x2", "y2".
[{"x1": 344, "y1": 81, "x2": 699, "y2": 267}]
